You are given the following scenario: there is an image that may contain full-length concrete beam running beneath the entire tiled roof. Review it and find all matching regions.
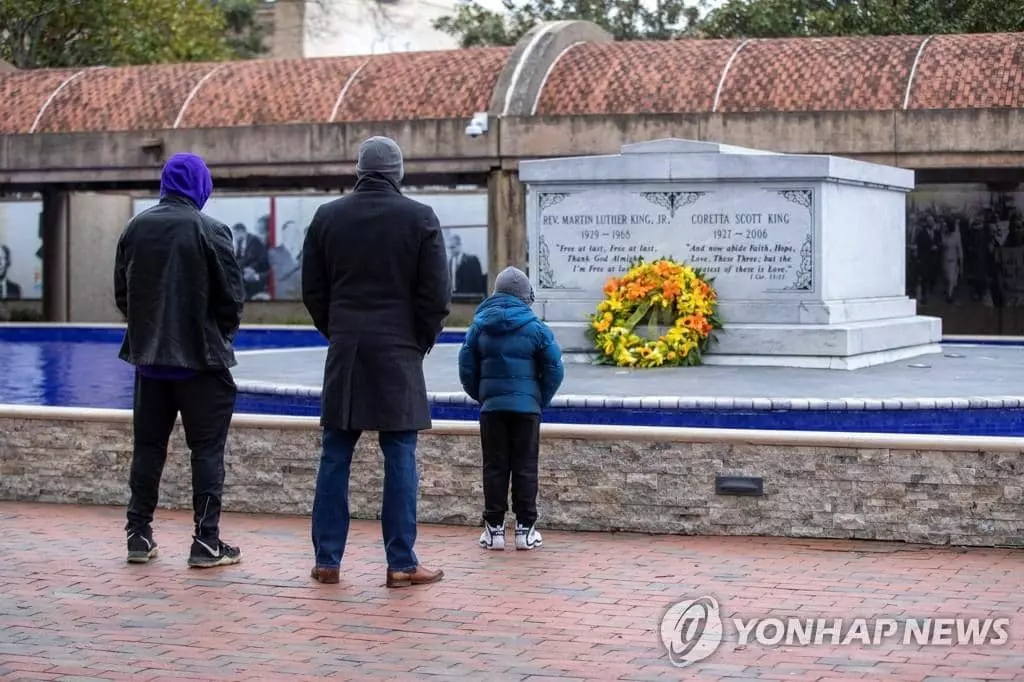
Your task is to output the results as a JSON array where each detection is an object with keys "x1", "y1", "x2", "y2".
[{"x1": 0, "y1": 109, "x2": 1024, "y2": 189}]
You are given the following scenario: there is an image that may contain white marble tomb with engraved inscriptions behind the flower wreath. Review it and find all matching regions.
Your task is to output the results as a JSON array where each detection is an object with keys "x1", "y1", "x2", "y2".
[{"x1": 519, "y1": 139, "x2": 942, "y2": 369}]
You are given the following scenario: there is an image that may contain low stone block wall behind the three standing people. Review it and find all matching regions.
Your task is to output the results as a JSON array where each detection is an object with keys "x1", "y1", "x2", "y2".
[{"x1": 0, "y1": 411, "x2": 1024, "y2": 546}]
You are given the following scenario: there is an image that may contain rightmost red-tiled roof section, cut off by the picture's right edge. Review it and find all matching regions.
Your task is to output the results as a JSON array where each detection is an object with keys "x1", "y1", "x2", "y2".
[{"x1": 908, "y1": 34, "x2": 1024, "y2": 109}]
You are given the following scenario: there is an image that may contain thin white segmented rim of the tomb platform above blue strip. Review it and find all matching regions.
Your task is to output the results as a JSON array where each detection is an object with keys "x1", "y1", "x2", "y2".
[{"x1": 237, "y1": 381, "x2": 1024, "y2": 411}]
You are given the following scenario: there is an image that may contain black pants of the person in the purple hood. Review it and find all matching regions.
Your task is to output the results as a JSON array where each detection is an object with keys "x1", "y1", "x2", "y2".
[{"x1": 125, "y1": 370, "x2": 238, "y2": 544}]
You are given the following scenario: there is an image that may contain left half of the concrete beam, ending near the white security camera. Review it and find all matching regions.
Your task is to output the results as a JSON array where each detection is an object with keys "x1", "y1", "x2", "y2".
[{"x1": 0, "y1": 120, "x2": 499, "y2": 185}]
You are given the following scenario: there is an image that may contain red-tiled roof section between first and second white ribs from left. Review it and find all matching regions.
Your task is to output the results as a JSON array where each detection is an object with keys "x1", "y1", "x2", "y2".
[{"x1": 38, "y1": 63, "x2": 215, "y2": 132}]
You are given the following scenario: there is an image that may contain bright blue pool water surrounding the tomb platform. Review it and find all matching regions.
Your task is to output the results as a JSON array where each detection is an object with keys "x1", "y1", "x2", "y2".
[{"x1": 6, "y1": 326, "x2": 1024, "y2": 436}]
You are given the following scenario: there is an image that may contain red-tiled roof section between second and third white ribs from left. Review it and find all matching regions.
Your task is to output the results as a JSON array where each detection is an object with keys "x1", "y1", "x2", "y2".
[{"x1": 180, "y1": 57, "x2": 366, "y2": 128}]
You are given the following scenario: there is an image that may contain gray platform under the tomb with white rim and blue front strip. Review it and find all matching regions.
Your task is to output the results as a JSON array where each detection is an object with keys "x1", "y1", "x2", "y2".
[{"x1": 233, "y1": 335, "x2": 1024, "y2": 436}]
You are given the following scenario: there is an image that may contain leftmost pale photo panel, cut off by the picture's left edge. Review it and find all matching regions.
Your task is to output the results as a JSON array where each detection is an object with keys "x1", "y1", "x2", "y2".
[{"x1": 0, "y1": 201, "x2": 43, "y2": 301}]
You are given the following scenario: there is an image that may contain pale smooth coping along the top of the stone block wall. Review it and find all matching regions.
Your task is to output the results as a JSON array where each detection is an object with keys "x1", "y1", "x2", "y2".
[{"x1": 0, "y1": 404, "x2": 1024, "y2": 454}]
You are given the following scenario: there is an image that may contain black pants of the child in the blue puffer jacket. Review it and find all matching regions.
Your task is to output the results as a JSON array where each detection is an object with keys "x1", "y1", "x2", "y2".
[{"x1": 480, "y1": 412, "x2": 541, "y2": 525}]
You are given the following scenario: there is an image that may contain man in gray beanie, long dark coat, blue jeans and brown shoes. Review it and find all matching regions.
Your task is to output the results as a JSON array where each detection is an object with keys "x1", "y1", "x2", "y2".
[{"x1": 302, "y1": 137, "x2": 451, "y2": 587}]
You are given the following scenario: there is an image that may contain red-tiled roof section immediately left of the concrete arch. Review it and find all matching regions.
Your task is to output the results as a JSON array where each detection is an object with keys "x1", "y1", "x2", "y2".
[{"x1": 336, "y1": 47, "x2": 512, "y2": 121}]
